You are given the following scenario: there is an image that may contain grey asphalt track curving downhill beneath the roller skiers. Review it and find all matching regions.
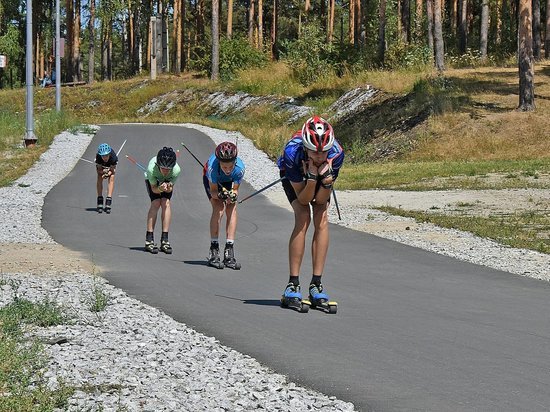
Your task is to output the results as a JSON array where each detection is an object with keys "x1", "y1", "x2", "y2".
[{"x1": 43, "y1": 125, "x2": 550, "y2": 411}]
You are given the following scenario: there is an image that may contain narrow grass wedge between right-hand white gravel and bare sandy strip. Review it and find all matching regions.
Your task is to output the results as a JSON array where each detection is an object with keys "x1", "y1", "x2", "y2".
[{"x1": 377, "y1": 206, "x2": 550, "y2": 253}]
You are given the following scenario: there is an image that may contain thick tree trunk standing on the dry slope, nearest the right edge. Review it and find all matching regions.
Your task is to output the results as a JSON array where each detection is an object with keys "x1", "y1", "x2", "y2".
[{"x1": 518, "y1": 0, "x2": 535, "y2": 111}]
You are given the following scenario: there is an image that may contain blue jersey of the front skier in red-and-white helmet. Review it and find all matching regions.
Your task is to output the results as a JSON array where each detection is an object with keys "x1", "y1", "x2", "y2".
[{"x1": 277, "y1": 132, "x2": 344, "y2": 183}]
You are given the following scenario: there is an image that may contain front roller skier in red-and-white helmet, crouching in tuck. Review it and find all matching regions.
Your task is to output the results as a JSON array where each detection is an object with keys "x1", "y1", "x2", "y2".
[{"x1": 277, "y1": 116, "x2": 344, "y2": 313}]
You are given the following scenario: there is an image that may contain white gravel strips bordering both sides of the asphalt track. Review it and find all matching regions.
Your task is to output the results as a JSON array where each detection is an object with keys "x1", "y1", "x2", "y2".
[{"x1": 0, "y1": 124, "x2": 550, "y2": 411}]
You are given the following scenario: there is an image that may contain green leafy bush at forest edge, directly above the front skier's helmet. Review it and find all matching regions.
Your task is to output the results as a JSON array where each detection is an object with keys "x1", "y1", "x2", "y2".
[{"x1": 283, "y1": 22, "x2": 334, "y2": 86}]
